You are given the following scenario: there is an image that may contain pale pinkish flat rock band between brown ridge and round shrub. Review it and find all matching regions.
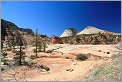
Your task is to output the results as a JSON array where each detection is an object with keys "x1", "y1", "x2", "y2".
[{"x1": 46, "y1": 45, "x2": 121, "y2": 57}]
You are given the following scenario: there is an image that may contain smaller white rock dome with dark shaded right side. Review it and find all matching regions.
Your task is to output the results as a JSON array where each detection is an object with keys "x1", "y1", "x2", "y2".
[{"x1": 60, "y1": 28, "x2": 77, "y2": 37}]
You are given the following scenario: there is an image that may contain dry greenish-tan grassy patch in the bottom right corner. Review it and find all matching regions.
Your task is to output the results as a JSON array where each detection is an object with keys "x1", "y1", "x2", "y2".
[{"x1": 86, "y1": 61, "x2": 121, "y2": 81}]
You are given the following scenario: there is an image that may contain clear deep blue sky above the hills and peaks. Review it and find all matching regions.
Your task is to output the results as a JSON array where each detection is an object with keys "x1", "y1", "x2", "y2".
[{"x1": 2, "y1": 1, "x2": 121, "y2": 36}]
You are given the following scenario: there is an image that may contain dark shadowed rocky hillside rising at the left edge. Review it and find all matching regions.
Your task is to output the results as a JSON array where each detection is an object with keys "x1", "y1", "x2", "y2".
[{"x1": 1, "y1": 19, "x2": 34, "y2": 45}]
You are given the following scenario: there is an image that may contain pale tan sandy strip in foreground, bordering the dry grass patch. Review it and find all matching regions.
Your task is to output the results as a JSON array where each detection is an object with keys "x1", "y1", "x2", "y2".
[{"x1": 28, "y1": 60, "x2": 112, "y2": 81}]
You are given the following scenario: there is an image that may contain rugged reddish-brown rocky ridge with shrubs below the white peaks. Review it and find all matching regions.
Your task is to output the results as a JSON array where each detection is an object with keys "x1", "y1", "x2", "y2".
[{"x1": 62, "y1": 33, "x2": 121, "y2": 44}]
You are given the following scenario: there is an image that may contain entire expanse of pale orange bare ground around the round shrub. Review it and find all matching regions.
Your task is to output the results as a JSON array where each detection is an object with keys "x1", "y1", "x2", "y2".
[{"x1": 2, "y1": 44, "x2": 120, "y2": 81}]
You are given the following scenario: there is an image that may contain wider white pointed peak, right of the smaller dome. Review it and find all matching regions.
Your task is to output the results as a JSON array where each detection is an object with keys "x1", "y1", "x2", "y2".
[{"x1": 77, "y1": 26, "x2": 104, "y2": 35}]
